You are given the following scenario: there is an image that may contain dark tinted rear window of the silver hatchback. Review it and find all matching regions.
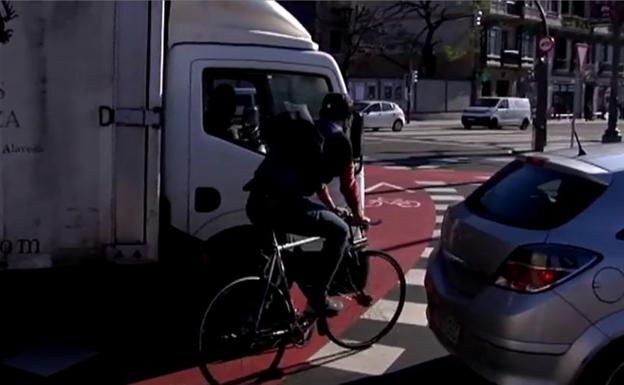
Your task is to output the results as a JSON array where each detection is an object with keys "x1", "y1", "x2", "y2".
[{"x1": 466, "y1": 161, "x2": 606, "y2": 230}]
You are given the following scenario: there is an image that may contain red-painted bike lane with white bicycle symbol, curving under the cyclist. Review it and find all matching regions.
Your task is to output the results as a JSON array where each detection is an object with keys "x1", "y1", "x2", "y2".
[{"x1": 136, "y1": 166, "x2": 488, "y2": 385}]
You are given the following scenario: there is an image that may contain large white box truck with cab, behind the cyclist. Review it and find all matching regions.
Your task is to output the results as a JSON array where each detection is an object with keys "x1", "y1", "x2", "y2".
[{"x1": 0, "y1": 0, "x2": 363, "y2": 270}]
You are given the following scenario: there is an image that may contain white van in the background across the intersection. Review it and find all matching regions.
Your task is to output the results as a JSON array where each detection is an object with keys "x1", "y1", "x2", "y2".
[{"x1": 461, "y1": 97, "x2": 531, "y2": 130}]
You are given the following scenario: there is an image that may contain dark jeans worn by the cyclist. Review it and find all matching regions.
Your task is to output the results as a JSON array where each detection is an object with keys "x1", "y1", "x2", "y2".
[{"x1": 247, "y1": 192, "x2": 349, "y2": 300}]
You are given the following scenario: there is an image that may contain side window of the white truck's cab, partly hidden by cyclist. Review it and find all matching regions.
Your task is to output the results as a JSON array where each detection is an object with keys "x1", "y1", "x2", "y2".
[{"x1": 202, "y1": 68, "x2": 331, "y2": 153}]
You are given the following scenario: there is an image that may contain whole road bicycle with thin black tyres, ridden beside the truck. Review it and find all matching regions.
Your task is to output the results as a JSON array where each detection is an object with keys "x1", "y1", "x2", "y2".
[{"x1": 199, "y1": 215, "x2": 406, "y2": 385}]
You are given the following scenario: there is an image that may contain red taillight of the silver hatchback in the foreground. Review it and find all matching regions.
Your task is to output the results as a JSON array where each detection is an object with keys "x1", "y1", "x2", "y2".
[{"x1": 495, "y1": 244, "x2": 600, "y2": 293}]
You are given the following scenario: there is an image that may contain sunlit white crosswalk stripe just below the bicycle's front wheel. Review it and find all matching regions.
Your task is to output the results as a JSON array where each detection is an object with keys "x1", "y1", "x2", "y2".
[{"x1": 308, "y1": 342, "x2": 405, "y2": 376}]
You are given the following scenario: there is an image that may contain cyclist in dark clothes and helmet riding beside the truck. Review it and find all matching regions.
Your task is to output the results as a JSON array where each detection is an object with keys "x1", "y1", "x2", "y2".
[{"x1": 246, "y1": 94, "x2": 370, "y2": 316}]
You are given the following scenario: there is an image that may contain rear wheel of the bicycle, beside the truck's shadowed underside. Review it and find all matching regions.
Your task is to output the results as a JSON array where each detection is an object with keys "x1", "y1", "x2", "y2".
[{"x1": 199, "y1": 277, "x2": 294, "y2": 385}]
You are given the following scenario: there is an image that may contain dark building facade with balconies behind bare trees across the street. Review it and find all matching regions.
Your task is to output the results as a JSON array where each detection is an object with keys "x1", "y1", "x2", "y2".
[{"x1": 280, "y1": 0, "x2": 624, "y2": 115}]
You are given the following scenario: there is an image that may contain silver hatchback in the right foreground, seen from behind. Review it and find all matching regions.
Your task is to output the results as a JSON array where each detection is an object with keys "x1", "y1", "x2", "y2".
[{"x1": 425, "y1": 144, "x2": 624, "y2": 385}]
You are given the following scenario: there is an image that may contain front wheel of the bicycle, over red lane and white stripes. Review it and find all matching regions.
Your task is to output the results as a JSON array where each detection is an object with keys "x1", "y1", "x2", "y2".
[{"x1": 319, "y1": 250, "x2": 406, "y2": 350}]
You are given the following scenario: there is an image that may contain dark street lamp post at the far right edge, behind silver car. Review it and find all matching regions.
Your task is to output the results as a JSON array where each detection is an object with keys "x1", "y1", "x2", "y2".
[{"x1": 602, "y1": 1, "x2": 624, "y2": 143}]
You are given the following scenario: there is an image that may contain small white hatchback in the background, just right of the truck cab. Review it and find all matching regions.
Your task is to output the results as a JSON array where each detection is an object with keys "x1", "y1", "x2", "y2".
[{"x1": 353, "y1": 100, "x2": 405, "y2": 132}]
